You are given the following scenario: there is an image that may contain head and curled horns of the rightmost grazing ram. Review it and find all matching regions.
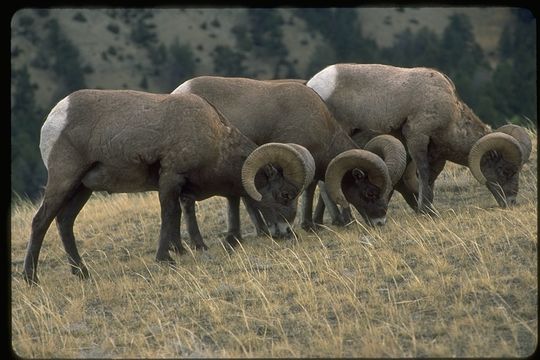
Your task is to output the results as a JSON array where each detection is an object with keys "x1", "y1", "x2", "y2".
[{"x1": 469, "y1": 125, "x2": 532, "y2": 208}]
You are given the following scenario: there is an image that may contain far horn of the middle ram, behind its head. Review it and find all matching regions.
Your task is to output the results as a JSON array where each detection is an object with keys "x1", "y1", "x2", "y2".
[{"x1": 364, "y1": 135, "x2": 407, "y2": 185}]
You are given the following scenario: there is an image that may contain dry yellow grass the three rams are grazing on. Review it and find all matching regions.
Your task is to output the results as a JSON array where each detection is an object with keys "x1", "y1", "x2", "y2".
[{"x1": 11, "y1": 130, "x2": 538, "y2": 358}]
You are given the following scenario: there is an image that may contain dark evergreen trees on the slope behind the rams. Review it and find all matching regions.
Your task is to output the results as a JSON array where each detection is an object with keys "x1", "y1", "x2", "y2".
[{"x1": 11, "y1": 8, "x2": 537, "y2": 199}]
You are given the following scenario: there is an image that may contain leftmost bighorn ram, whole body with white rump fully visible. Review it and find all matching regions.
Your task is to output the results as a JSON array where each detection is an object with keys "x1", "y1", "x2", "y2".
[{"x1": 24, "y1": 90, "x2": 315, "y2": 282}]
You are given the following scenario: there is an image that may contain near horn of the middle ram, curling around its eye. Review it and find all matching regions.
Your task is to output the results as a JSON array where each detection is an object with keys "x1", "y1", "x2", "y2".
[{"x1": 324, "y1": 149, "x2": 392, "y2": 207}]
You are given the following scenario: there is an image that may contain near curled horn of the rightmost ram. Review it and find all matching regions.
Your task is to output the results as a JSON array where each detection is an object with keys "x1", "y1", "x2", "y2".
[{"x1": 469, "y1": 132, "x2": 524, "y2": 184}]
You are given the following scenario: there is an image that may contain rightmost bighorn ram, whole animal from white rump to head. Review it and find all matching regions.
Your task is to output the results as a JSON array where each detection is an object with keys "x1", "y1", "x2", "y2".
[{"x1": 306, "y1": 64, "x2": 531, "y2": 213}]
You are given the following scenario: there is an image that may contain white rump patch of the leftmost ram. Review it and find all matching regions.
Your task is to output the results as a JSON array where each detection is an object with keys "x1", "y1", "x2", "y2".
[{"x1": 39, "y1": 96, "x2": 69, "y2": 169}]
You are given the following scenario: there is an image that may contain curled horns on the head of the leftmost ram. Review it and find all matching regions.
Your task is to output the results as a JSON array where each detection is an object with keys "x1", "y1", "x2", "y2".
[{"x1": 242, "y1": 143, "x2": 315, "y2": 201}]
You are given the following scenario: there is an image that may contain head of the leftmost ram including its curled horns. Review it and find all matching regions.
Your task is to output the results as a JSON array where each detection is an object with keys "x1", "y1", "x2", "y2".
[{"x1": 242, "y1": 143, "x2": 315, "y2": 237}]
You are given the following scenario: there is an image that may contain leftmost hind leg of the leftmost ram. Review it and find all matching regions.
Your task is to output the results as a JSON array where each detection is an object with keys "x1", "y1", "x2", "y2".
[{"x1": 23, "y1": 165, "x2": 85, "y2": 284}]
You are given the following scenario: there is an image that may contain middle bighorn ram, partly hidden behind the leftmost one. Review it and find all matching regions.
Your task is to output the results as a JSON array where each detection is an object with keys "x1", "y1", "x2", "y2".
[{"x1": 173, "y1": 76, "x2": 405, "y2": 244}]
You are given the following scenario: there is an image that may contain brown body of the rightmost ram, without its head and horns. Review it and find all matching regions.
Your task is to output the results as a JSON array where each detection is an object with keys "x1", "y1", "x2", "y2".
[{"x1": 307, "y1": 64, "x2": 491, "y2": 212}]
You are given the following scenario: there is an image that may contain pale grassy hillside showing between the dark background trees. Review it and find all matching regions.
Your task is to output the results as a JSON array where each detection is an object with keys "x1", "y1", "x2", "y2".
[{"x1": 11, "y1": 7, "x2": 511, "y2": 108}]
